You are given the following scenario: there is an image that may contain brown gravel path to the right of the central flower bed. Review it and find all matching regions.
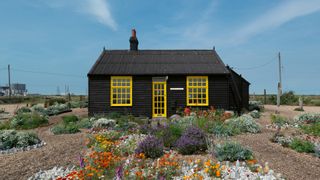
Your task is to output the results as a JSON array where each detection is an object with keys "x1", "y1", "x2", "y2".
[{"x1": 232, "y1": 106, "x2": 320, "y2": 180}]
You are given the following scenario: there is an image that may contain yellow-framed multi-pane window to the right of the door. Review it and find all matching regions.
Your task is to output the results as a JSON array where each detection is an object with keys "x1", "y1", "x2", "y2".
[{"x1": 187, "y1": 76, "x2": 209, "y2": 106}]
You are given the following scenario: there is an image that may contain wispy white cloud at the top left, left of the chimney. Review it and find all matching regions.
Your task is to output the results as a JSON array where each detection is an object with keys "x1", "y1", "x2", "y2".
[{"x1": 38, "y1": 0, "x2": 117, "y2": 31}]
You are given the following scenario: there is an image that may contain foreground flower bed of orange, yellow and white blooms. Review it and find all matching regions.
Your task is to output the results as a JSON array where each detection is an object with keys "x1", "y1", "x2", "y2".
[{"x1": 47, "y1": 124, "x2": 281, "y2": 180}]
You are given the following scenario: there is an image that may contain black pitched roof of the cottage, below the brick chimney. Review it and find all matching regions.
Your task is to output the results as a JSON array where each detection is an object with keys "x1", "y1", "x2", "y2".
[{"x1": 88, "y1": 50, "x2": 230, "y2": 76}]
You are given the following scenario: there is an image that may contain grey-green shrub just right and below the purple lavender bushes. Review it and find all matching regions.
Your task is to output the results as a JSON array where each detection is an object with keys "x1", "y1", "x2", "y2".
[{"x1": 215, "y1": 142, "x2": 253, "y2": 162}]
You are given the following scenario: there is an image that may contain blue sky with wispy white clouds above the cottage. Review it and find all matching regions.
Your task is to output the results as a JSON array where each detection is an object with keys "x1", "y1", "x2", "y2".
[{"x1": 0, "y1": 0, "x2": 320, "y2": 95}]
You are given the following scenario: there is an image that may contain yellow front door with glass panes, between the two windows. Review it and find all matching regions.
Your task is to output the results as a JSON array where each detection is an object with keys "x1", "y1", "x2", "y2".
[{"x1": 152, "y1": 81, "x2": 167, "y2": 117}]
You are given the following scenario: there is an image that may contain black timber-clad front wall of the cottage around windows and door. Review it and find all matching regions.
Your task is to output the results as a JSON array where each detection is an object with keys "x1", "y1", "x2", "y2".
[{"x1": 89, "y1": 75, "x2": 229, "y2": 117}]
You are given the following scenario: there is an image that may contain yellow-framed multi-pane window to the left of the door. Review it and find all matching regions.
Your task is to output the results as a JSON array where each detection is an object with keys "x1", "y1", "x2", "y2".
[{"x1": 110, "y1": 76, "x2": 132, "y2": 106}]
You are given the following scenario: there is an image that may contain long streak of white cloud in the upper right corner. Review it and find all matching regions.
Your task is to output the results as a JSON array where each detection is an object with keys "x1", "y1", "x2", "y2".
[{"x1": 230, "y1": 0, "x2": 320, "y2": 44}]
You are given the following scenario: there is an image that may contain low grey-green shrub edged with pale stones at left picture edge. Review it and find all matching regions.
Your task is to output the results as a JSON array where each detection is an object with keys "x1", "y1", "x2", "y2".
[{"x1": 0, "y1": 130, "x2": 41, "y2": 150}]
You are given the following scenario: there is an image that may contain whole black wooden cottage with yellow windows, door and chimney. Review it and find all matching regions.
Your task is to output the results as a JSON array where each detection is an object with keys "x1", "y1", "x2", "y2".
[{"x1": 88, "y1": 30, "x2": 250, "y2": 117}]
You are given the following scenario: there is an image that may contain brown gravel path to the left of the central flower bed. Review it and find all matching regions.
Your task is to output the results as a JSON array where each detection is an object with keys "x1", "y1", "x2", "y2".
[{"x1": 0, "y1": 109, "x2": 87, "y2": 180}]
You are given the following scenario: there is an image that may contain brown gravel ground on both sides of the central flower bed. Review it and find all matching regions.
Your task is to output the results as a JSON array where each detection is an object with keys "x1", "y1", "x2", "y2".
[{"x1": 0, "y1": 105, "x2": 320, "y2": 180}]
